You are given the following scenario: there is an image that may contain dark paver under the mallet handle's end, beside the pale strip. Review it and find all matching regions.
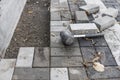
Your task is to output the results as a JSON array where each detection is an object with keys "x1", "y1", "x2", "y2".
[{"x1": 93, "y1": 37, "x2": 108, "y2": 46}]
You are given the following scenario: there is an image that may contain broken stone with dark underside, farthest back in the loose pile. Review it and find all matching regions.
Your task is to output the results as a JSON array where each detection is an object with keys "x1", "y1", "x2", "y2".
[{"x1": 80, "y1": 4, "x2": 100, "y2": 14}]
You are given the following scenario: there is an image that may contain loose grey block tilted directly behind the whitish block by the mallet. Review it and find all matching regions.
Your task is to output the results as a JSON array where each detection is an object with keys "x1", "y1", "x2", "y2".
[{"x1": 75, "y1": 11, "x2": 89, "y2": 23}]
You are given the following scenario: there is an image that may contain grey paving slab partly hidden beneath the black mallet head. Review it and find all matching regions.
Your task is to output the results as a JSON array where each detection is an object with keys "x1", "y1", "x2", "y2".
[{"x1": 50, "y1": 32, "x2": 79, "y2": 48}]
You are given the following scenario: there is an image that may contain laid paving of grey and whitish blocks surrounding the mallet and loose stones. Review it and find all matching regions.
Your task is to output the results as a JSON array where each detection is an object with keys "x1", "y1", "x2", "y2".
[{"x1": 0, "y1": 0, "x2": 120, "y2": 80}]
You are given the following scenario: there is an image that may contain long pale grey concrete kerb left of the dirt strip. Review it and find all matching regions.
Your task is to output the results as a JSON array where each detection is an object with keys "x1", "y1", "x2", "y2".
[{"x1": 0, "y1": 0, "x2": 27, "y2": 57}]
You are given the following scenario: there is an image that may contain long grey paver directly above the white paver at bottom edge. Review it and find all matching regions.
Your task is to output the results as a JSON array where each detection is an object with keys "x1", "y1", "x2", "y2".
[{"x1": 51, "y1": 57, "x2": 82, "y2": 67}]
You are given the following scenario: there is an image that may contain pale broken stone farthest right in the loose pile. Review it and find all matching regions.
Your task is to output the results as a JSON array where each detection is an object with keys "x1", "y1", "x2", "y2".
[{"x1": 102, "y1": 8, "x2": 118, "y2": 18}]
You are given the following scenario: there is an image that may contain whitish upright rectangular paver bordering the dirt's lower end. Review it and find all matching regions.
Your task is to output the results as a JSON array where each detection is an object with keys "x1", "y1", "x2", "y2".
[{"x1": 16, "y1": 47, "x2": 34, "y2": 67}]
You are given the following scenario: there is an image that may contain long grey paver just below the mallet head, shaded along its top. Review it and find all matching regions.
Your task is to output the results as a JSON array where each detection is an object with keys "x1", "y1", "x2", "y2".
[{"x1": 51, "y1": 48, "x2": 81, "y2": 56}]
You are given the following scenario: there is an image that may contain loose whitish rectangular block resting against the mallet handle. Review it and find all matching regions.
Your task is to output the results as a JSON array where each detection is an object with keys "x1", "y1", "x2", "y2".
[{"x1": 70, "y1": 23, "x2": 99, "y2": 35}]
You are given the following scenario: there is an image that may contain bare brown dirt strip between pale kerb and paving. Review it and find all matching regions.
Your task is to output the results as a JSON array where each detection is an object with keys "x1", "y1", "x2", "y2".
[{"x1": 5, "y1": 0, "x2": 50, "y2": 58}]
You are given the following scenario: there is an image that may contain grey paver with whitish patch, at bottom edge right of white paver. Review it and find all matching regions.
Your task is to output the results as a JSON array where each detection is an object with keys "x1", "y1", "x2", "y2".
[{"x1": 69, "y1": 68, "x2": 88, "y2": 80}]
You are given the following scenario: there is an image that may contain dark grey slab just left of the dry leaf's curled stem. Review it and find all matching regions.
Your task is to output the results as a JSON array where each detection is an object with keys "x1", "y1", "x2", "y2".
[{"x1": 81, "y1": 47, "x2": 96, "y2": 66}]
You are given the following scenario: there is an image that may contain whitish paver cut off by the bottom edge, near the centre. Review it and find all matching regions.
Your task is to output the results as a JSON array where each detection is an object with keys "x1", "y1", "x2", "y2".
[{"x1": 51, "y1": 68, "x2": 69, "y2": 80}]
